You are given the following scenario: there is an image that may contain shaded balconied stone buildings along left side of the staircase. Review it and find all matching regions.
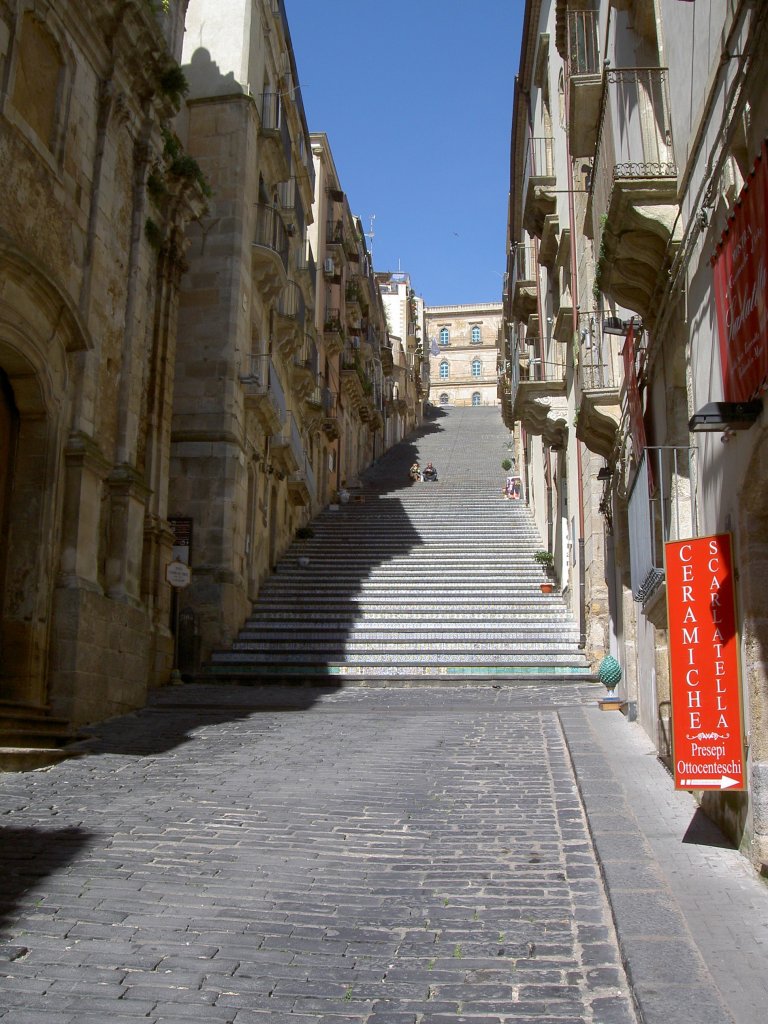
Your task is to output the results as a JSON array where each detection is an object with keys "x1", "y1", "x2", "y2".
[{"x1": 170, "y1": 0, "x2": 397, "y2": 673}]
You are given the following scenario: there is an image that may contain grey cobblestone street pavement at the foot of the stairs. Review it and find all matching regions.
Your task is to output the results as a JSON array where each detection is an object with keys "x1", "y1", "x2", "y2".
[{"x1": 0, "y1": 685, "x2": 768, "y2": 1024}]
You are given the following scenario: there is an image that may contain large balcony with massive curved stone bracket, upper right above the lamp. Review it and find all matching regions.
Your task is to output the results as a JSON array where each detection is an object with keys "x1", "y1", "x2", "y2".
[{"x1": 585, "y1": 68, "x2": 679, "y2": 325}]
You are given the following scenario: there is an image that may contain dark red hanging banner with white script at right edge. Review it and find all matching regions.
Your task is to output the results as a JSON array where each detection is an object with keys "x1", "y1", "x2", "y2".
[{"x1": 712, "y1": 142, "x2": 768, "y2": 401}]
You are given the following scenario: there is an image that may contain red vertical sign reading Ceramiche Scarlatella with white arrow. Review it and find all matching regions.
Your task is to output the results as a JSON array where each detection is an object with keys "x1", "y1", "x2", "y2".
[{"x1": 665, "y1": 534, "x2": 746, "y2": 790}]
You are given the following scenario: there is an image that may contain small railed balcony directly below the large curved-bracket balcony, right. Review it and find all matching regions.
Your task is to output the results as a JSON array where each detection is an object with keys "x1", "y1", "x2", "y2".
[{"x1": 575, "y1": 313, "x2": 625, "y2": 459}]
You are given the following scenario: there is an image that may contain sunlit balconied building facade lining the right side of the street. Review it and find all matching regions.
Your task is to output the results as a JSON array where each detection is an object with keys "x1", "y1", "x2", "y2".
[{"x1": 500, "y1": 0, "x2": 768, "y2": 866}]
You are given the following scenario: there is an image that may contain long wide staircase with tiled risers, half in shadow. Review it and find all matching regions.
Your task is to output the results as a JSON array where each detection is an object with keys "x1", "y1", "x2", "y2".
[{"x1": 204, "y1": 409, "x2": 594, "y2": 684}]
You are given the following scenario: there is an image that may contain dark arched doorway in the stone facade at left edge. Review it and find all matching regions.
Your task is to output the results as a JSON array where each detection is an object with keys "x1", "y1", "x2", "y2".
[{"x1": 0, "y1": 247, "x2": 87, "y2": 716}]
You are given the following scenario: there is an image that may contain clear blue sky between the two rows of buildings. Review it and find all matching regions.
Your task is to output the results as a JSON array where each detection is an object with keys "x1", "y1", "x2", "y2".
[{"x1": 285, "y1": 0, "x2": 524, "y2": 305}]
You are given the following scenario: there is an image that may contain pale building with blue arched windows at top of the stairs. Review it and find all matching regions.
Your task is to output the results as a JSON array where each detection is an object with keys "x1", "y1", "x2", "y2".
[{"x1": 424, "y1": 302, "x2": 502, "y2": 406}]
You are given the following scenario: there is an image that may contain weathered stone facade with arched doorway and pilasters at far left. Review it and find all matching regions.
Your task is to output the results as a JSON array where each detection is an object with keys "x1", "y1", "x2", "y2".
[{"x1": 0, "y1": 0, "x2": 204, "y2": 737}]
